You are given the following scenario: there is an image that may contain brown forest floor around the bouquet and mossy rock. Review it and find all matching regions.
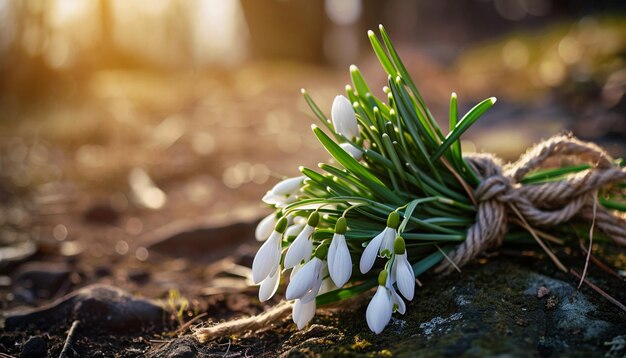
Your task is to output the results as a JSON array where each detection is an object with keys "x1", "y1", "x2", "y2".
[{"x1": 0, "y1": 16, "x2": 626, "y2": 357}]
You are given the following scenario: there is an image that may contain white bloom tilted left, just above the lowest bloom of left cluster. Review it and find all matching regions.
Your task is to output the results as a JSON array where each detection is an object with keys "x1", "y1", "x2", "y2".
[{"x1": 285, "y1": 257, "x2": 325, "y2": 303}]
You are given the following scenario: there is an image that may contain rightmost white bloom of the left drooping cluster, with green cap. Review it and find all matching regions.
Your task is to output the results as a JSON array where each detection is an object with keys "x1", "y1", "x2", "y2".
[{"x1": 328, "y1": 217, "x2": 352, "y2": 287}]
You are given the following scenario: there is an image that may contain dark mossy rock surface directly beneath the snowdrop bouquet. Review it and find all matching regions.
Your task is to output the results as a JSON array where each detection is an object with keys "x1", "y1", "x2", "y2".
[{"x1": 145, "y1": 259, "x2": 626, "y2": 357}]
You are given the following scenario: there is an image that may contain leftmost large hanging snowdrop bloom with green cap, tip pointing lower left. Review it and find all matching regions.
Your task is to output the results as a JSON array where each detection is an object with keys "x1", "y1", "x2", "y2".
[{"x1": 252, "y1": 217, "x2": 287, "y2": 284}]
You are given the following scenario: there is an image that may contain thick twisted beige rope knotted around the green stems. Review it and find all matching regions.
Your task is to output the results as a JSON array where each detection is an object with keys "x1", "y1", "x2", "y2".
[{"x1": 436, "y1": 135, "x2": 626, "y2": 272}]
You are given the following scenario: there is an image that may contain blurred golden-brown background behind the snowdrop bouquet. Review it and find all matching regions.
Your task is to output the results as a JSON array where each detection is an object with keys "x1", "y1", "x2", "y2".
[{"x1": 0, "y1": 0, "x2": 626, "y2": 304}]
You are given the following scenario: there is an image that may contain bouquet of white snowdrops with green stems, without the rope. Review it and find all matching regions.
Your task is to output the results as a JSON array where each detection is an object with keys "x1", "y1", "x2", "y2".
[{"x1": 252, "y1": 26, "x2": 624, "y2": 333}]
